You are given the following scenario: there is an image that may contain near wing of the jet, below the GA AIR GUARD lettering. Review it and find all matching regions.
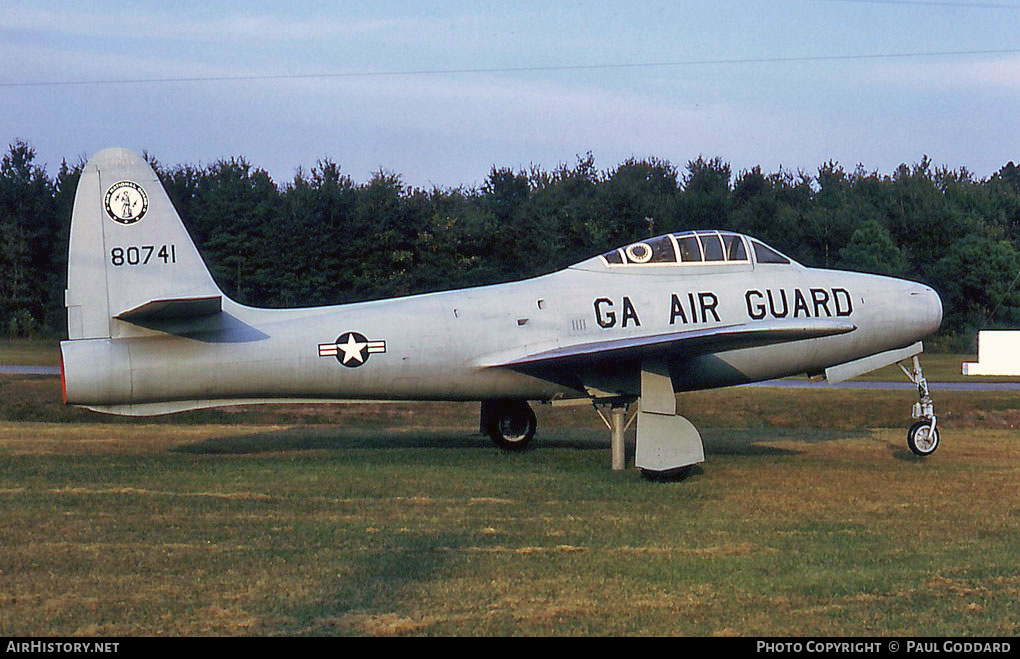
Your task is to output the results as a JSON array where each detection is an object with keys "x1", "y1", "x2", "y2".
[{"x1": 482, "y1": 318, "x2": 857, "y2": 372}]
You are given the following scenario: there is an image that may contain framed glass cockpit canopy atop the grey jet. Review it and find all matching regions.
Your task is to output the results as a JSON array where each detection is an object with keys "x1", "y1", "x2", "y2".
[{"x1": 599, "y1": 231, "x2": 792, "y2": 267}]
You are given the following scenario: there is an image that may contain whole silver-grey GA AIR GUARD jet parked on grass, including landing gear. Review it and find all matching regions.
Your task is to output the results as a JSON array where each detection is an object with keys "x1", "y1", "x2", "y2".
[{"x1": 60, "y1": 149, "x2": 942, "y2": 476}]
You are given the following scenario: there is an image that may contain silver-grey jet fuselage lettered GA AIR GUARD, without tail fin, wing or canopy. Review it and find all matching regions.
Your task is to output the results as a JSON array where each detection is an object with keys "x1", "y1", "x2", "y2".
[{"x1": 63, "y1": 242, "x2": 941, "y2": 418}]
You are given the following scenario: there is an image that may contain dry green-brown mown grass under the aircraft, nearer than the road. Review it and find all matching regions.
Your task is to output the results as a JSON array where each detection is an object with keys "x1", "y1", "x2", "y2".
[{"x1": 0, "y1": 369, "x2": 1020, "y2": 636}]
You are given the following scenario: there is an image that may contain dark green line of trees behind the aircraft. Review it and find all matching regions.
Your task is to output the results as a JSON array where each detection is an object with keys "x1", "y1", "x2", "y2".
[{"x1": 0, "y1": 141, "x2": 1020, "y2": 350}]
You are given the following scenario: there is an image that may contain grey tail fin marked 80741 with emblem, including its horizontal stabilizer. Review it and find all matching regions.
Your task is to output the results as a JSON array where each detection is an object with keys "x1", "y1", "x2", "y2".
[{"x1": 65, "y1": 149, "x2": 222, "y2": 340}]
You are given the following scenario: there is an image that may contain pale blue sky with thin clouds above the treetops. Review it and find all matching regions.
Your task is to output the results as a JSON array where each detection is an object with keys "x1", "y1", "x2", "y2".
[{"x1": 0, "y1": 0, "x2": 1020, "y2": 188}]
